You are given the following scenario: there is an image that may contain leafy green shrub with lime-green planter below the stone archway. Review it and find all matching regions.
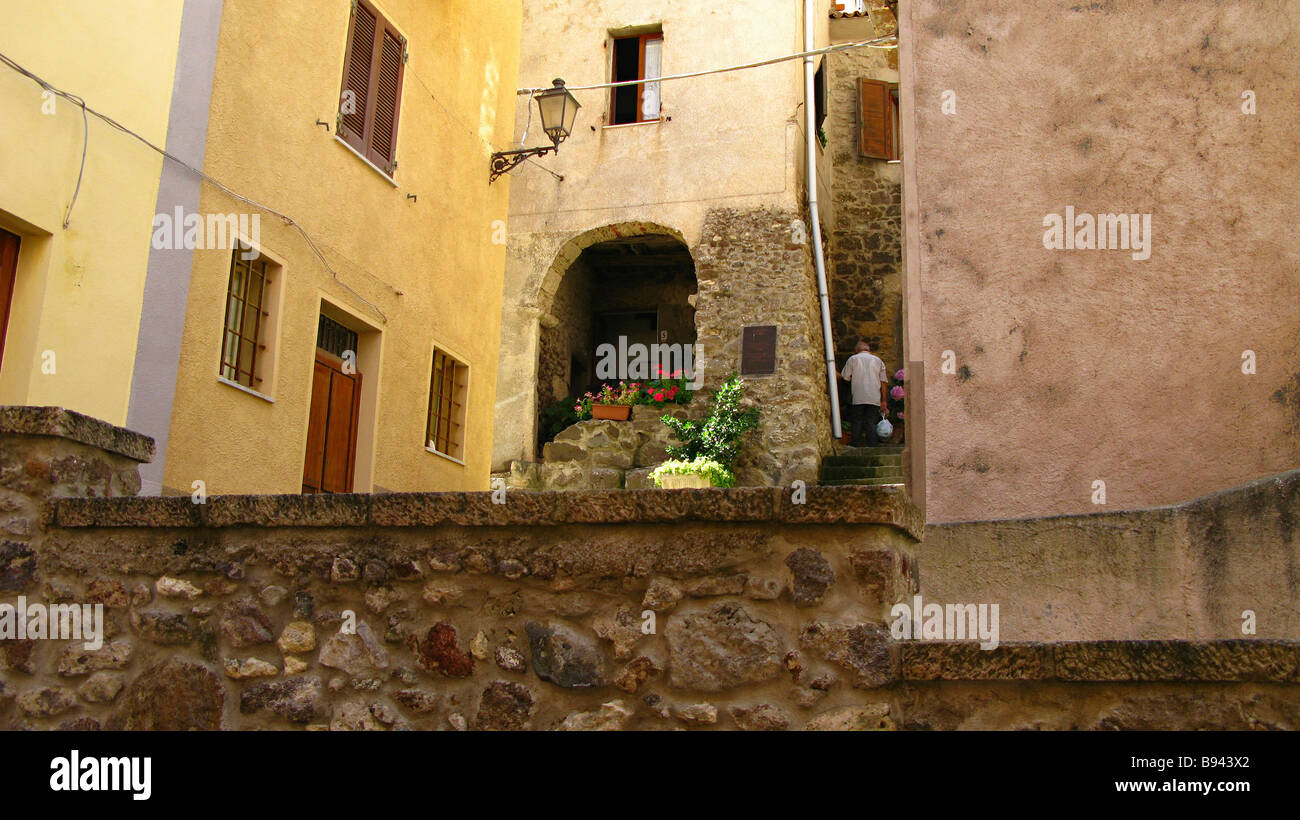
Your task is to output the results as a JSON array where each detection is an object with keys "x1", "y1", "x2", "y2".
[{"x1": 651, "y1": 373, "x2": 758, "y2": 489}]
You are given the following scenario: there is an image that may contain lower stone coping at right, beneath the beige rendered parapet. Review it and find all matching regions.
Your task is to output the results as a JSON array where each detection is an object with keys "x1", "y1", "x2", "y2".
[{"x1": 902, "y1": 639, "x2": 1300, "y2": 684}]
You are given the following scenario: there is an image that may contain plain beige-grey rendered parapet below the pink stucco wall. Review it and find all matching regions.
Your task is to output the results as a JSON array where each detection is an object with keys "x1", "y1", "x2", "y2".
[{"x1": 918, "y1": 470, "x2": 1300, "y2": 641}]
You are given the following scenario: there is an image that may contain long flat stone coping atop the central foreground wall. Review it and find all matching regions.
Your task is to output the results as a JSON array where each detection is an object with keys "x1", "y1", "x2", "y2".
[{"x1": 52, "y1": 486, "x2": 924, "y2": 541}]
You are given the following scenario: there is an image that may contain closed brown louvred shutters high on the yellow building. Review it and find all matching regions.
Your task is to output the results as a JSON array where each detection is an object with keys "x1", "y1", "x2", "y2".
[{"x1": 338, "y1": 0, "x2": 407, "y2": 174}]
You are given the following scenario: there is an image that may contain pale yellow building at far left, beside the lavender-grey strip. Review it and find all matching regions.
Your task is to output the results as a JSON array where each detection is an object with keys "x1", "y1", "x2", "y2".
[{"x1": 0, "y1": 0, "x2": 182, "y2": 424}]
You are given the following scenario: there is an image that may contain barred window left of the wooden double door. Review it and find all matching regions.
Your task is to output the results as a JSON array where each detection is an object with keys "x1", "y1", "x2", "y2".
[{"x1": 220, "y1": 242, "x2": 272, "y2": 391}]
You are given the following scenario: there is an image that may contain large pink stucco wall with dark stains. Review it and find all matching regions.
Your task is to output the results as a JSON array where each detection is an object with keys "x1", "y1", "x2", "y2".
[{"x1": 900, "y1": 0, "x2": 1300, "y2": 522}]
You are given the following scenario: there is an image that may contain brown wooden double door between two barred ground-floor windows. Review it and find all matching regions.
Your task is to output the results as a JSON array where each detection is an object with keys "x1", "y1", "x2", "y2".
[{"x1": 303, "y1": 350, "x2": 361, "y2": 493}]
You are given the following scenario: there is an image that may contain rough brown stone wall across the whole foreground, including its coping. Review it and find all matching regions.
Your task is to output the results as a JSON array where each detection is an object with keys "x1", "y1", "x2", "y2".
[{"x1": 0, "y1": 408, "x2": 1300, "y2": 730}]
